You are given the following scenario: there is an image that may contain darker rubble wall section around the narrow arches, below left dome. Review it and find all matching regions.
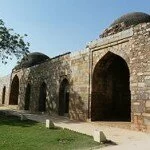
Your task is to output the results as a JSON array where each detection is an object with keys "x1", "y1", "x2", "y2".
[{"x1": 14, "y1": 55, "x2": 70, "y2": 113}]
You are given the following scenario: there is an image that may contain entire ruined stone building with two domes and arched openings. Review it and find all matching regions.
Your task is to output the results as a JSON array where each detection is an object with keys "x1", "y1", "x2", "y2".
[{"x1": 0, "y1": 12, "x2": 150, "y2": 131}]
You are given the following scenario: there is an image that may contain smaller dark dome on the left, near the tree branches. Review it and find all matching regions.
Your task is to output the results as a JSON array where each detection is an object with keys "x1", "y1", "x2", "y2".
[{"x1": 15, "y1": 52, "x2": 49, "y2": 69}]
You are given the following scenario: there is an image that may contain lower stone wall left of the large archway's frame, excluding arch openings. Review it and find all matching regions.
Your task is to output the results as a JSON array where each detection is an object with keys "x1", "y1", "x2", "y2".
[{"x1": 12, "y1": 49, "x2": 89, "y2": 120}]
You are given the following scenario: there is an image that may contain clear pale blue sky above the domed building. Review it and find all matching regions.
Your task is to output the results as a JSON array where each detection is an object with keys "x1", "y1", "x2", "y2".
[{"x1": 0, "y1": 0, "x2": 150, "y2": 76}]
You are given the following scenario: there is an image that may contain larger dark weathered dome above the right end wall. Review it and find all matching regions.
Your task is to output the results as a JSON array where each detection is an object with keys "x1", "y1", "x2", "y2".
[{"x1": 110, "y1": 12, "x2": 150, "y2": 26}]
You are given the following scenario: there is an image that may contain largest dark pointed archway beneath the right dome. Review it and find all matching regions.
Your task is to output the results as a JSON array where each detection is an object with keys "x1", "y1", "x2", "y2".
[{"x1": 91, "y1": 52, "x2": 131, "y2": 121}]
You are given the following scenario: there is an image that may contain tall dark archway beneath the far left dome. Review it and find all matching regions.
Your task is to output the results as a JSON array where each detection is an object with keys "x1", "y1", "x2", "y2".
[{"x1": 9, "y1": 75, "x2": 19, "y2": 105}]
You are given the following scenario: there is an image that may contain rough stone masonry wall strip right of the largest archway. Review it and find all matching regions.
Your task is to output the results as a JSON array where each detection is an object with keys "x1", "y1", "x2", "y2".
[{"x1": 130, "y1": 23, "x2": 150, "y2": 130}]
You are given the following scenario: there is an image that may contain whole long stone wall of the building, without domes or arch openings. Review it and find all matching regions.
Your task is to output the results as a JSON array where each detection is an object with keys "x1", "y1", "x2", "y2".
[{"x1": 1, "y1": 23, "x2": 150, "y2": 130}]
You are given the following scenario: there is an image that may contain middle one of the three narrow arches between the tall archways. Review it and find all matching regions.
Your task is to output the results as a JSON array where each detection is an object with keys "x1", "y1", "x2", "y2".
[{"x1": 39, "y1": 82, "x2": 46, "y2": 112}]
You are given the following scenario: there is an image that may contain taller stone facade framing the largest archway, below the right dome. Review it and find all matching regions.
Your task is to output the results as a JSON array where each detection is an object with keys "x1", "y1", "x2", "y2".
[{"x1": 88, "y1": 23, "x2": 150, "y2": 130}]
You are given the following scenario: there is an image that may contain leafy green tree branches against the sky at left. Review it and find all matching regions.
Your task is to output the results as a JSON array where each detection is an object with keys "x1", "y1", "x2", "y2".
[{"x1": 0, "y1": 19, "x2": 30, "y2": 64}]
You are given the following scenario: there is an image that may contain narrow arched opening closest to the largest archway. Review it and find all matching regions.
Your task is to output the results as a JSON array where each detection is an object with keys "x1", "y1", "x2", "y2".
[{"x1": 58, "y1": 79, "x2": 69, "y2": 116}]
